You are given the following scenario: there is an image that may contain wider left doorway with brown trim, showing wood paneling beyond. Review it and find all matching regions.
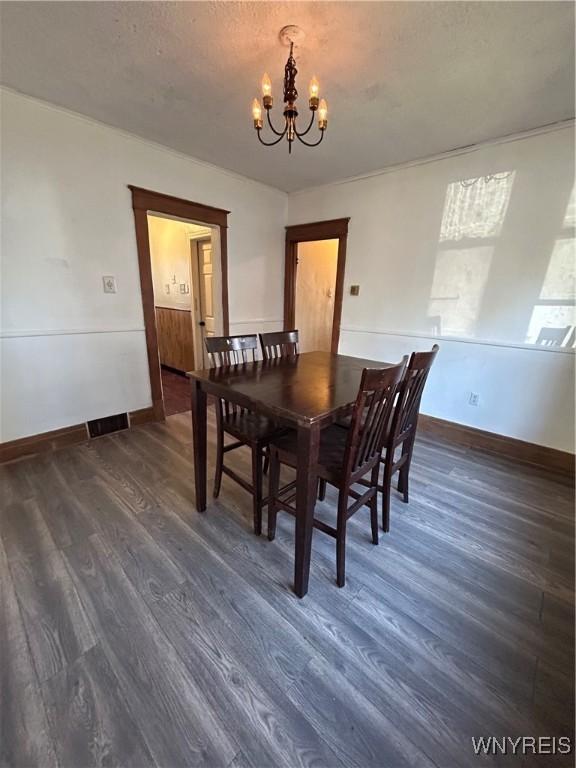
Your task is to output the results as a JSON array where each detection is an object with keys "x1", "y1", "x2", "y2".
[{"x1": 129, "y1": 186, "x2": 229, "y2": 420}]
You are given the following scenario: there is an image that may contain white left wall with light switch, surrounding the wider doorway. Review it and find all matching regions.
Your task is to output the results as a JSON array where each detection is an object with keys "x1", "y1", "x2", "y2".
[{"x1": 0, "y1": 90, "x2": 286, "y2": 441}]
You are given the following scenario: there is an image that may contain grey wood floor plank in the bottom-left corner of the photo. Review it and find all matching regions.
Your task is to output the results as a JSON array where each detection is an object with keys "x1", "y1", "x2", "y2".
[{"x1": 0, "y1": 541, "x2": 58, "y2": 768}]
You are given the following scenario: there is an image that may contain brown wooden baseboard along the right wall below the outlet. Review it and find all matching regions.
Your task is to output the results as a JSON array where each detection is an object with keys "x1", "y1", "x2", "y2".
[{"x1": 418, "y1": 414, "x2": 575, "y2": 476}]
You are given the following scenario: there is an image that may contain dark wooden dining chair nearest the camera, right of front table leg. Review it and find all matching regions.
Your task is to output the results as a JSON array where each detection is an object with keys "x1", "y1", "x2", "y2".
[{"x1": 268, "y1": 356, "x2": 408, "y2": 587}]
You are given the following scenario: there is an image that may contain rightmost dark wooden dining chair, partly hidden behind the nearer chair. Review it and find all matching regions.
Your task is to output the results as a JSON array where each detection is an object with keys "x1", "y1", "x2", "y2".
[{"x1": 379, "y1": 344, "x2": 439, "y2": 533}]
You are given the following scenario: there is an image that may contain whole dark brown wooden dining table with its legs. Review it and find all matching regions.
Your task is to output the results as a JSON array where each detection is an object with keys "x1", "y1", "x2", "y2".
[{"x1": 188, "y1": 352, "x2": 393, "y2": 597}]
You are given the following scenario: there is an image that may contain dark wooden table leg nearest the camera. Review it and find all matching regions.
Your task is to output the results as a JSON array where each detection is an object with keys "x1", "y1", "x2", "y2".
[{"x1": 294, "y1": 425, "x2": 320, "y2": 597}]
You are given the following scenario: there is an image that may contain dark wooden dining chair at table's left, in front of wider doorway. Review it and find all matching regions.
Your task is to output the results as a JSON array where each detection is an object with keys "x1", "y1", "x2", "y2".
[{"x1": 205, "y1": 334, "x2": 279, "y2": 536}]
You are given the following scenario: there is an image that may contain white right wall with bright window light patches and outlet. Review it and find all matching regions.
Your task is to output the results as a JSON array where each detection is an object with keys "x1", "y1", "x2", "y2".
[{"x1": 288, "y1": 127, "x2": 574, "y2": 451}]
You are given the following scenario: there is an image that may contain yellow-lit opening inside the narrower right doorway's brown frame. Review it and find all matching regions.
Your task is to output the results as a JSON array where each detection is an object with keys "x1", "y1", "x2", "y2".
[{"x1": 294, "y1": 239, "x2": 338, "y2": 352}]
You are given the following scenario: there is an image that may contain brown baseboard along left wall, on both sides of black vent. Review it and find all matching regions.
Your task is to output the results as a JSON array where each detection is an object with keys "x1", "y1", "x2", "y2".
[{"x1": 0, "y1": 405, "x2": 164, "y2": 464}]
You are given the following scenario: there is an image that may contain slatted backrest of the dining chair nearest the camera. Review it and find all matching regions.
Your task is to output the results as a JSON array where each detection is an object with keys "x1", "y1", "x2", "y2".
[{"x1": 344, "y1": 356, "x2": 408, "y2": 478}]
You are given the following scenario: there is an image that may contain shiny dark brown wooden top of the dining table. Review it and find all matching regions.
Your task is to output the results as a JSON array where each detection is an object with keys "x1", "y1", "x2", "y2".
[{"x1": 187, "y1": 352, "x2": 394, "y2": 424}]
